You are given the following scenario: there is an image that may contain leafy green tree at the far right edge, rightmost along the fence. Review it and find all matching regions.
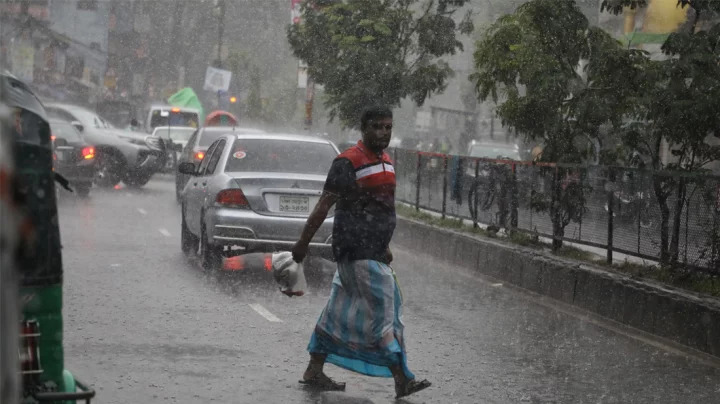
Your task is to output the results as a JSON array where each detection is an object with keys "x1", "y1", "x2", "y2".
[{"x1": 602, "y1": 0, "x2": 720, "y2": 264}]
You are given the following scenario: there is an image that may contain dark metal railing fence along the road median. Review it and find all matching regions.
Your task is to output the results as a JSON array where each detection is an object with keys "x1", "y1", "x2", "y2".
[{"x1": 391, "y1": 149, "x2": 720, "y2": 274}]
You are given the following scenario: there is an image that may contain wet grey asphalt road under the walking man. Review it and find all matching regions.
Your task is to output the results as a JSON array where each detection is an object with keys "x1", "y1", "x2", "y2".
[{"x1": 54, "y1": 177, "x2": 720, "y2": 403}]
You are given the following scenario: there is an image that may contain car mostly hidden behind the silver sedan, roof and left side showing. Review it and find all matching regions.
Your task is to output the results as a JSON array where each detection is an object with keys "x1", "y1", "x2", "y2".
[{"x1": 175, "y1": 126, "x2": 265, "y2": 202}]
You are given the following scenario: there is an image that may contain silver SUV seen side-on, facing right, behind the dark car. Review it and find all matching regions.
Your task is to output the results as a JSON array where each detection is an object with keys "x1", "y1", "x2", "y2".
[{"x1": 45, "y1": 103, "x2": 166, "y2": 187}]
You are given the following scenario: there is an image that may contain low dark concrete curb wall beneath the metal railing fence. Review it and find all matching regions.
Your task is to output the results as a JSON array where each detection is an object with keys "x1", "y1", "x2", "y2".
[{"x1": 393, "y1": 216, "x2": 720, "y2": 357}]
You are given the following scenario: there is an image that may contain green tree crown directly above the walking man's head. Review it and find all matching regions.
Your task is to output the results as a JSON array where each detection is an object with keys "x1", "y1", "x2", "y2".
[{"x1": 287, "y1": 0, "x2": 472, "y2": 127}]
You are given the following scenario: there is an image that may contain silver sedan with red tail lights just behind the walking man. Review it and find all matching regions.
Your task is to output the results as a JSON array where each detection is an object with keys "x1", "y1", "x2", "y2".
[{"x1": 178, "y1": 134, "x2": 338, "y2": 269}]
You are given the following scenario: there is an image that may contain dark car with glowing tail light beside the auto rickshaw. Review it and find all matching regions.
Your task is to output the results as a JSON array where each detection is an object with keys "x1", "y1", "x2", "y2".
[{"x1": 50, "y1": 120, "x2": 96, "y2": 196}]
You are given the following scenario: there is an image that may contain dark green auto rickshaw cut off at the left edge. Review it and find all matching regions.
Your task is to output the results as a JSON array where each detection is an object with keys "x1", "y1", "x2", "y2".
[{"x1": 0, "y1": 73, "x2": 95, "y2": 403}]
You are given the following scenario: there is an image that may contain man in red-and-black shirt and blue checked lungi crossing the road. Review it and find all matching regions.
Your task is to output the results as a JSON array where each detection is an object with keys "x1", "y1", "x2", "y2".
[{"x1": 292, "y1": 107, "x2": 430, "y2": 397}]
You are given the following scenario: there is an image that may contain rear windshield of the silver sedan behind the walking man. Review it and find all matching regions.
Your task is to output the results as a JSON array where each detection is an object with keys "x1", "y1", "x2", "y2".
[{"x1": 225, "y1": 139, "x2": 337, "y2": 175}]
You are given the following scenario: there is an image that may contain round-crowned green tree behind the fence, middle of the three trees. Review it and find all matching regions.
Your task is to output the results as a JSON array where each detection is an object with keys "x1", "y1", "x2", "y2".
[{"x1": 470, "y1": 0, "x2": 628, "y2": 249}]
